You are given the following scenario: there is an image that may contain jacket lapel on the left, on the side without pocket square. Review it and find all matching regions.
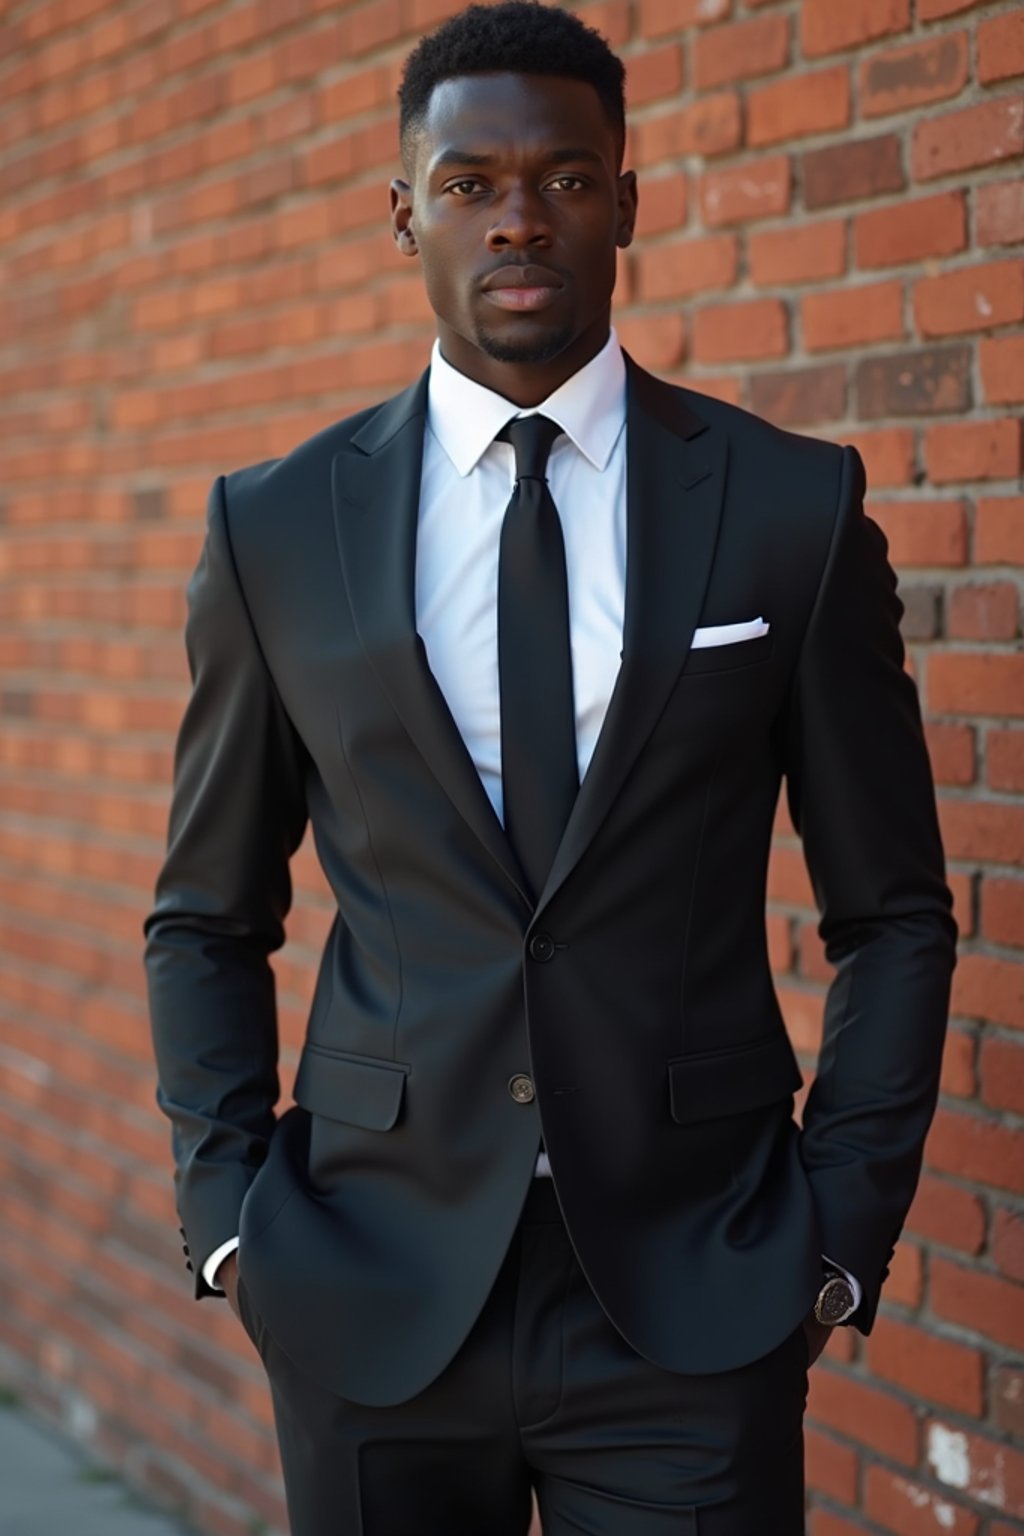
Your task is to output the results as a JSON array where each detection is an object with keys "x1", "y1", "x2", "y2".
[{"x1": 332, "y1": 373, "x2": 533, "y2": 905}]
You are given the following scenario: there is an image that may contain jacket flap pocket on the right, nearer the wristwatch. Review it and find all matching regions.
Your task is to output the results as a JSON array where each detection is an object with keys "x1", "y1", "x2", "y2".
[{"x1": 668, "y1": 1034, "x2": 803, "y2": 1126}]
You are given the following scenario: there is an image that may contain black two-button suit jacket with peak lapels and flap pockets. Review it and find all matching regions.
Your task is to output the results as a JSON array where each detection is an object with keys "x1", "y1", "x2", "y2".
[{"x1": 146, "y1": 364, "x2": 955, "y2": 1404}]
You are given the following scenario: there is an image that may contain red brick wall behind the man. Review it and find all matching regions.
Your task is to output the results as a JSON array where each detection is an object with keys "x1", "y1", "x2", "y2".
[{"x1": 0, "y1": 0, "x2": 1024, "y2": 1536}]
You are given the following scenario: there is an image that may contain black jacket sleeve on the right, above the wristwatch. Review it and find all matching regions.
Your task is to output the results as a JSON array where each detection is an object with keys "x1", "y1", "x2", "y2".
[{"x1": 786, "y1": 449, "x2": 956, "y2": 1332}]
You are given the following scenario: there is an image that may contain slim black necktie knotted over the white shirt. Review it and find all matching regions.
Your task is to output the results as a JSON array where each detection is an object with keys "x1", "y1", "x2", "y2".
[{"x1": 497, "y1": 416, "x2": 579, "y2": 897}]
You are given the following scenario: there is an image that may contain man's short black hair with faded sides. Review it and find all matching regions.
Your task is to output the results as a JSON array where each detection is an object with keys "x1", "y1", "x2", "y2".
[{"x1": 398, "y1": 0, "x2": 626, "y2": 163}]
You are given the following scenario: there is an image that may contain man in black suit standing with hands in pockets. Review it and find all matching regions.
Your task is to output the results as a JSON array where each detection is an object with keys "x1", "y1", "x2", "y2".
[{"x1": 147, "y1": 0, "x2": 955, "y2": 1536}]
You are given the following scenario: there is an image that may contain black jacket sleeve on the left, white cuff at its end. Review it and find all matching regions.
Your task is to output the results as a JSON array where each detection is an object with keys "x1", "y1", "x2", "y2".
[{"x1": 144, "y1": 476, "x2": 307, "y2": 1296}]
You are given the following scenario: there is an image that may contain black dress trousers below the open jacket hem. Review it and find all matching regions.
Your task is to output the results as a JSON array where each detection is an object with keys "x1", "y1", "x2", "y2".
[{"x1": 238, "y1": 1178, "x2": 808, "y2": 1536}]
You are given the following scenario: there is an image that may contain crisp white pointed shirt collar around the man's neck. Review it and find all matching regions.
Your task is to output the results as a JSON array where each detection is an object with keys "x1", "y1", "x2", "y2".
[{"x1": 427, "y1": 329, "x2": 626, "y2": 476}]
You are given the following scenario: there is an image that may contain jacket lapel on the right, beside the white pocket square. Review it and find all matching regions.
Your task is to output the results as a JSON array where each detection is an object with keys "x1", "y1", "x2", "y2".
[{"x1": 539, "y1": 359, "x2": 726, "y2": 908}]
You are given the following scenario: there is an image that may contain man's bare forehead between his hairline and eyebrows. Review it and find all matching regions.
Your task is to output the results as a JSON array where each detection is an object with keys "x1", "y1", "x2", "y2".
[{"x1": 422, "y1": 74, "x2": 616, "y2": 161}]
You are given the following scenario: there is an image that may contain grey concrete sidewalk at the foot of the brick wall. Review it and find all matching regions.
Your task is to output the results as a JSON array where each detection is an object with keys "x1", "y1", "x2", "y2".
[{"x1": 0, "y1": 1404, "x2": 192, "y2": 1536}]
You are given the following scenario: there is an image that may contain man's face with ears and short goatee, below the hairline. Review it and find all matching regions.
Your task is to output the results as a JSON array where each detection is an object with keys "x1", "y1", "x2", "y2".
[{"x1": 391, "y1": 74, "x2": 636, "y2": 404}]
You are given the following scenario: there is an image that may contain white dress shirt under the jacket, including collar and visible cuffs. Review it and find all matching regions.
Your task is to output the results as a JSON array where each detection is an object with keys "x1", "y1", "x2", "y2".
[{"x1": 203, "y1": 330, "x2": 860, "y2": 1301}]
